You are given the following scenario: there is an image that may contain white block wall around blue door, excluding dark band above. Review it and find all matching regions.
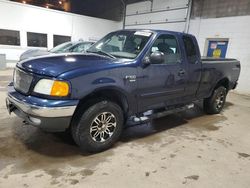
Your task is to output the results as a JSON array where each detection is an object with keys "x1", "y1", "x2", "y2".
[{"x1": 189, "y1": 16, "x2": 250, "y2": 94}]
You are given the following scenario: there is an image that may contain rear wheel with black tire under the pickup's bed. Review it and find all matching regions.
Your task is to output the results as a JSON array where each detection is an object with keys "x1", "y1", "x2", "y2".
[{"x1": 203, "y1": 86, "x2": 227, "y2": 114}]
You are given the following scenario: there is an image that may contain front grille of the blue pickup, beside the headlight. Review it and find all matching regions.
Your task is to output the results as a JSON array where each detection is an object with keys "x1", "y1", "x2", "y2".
[{"x1": 14, "y1": 69, "x2": 33, "y2": 94}]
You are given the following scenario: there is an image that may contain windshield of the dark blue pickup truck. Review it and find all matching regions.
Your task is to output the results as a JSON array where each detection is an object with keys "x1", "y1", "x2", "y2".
[{"x1": 87, "y1": 31, "x2": 152, "y2": 59}]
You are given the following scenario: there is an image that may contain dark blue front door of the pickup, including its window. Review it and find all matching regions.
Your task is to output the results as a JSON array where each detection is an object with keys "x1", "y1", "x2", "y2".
[{"x1": 137, "y1": 34, "x2": 186, "y2": 112}]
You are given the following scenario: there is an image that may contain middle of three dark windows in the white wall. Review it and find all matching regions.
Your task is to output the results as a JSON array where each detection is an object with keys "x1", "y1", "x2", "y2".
[{"x1": 27, "y1": 32, "x2": 47, "y2": 48}]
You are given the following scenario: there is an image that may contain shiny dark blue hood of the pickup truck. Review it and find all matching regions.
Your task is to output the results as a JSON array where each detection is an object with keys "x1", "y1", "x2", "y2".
[{"x1": 17, "y1": 54, "x2": 124, "y2": 77}]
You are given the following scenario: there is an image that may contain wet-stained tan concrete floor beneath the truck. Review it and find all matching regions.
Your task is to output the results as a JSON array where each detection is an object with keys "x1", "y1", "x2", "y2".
[{"x1": 0, "y1": 70, "x2": 250, "y2": 188}]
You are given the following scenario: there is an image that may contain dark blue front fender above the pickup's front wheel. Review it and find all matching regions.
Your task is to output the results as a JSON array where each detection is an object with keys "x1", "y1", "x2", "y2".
[{"x1": 70, "y1": 67, "x2": 137, "y2": 115}]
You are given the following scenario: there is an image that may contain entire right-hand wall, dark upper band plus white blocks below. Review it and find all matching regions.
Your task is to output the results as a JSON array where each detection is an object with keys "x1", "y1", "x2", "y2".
[{"x1": 189, "y1": 0, "x2": 250, "y2": 94}]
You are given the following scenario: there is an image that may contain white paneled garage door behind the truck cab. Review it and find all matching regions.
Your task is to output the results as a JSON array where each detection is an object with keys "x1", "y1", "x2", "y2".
[{"x1": 125, "y1": 0, "x2": 191, "y2": 32}]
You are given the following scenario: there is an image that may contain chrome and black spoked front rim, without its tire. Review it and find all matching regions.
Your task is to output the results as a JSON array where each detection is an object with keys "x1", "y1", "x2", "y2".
[{"x1": 90, "y1": 112, "x2": 117, "y2": 142}]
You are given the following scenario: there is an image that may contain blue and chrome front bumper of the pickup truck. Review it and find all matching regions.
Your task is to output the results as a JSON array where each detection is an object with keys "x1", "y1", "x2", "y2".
[{"x1": 6, "y1": 86, "x2": 79, "y2": 132}]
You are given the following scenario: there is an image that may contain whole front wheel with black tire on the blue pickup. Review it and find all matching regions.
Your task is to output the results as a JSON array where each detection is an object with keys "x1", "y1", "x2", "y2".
[{"x1": 71, "y1": 100, "x2": 124, "y2": 153}]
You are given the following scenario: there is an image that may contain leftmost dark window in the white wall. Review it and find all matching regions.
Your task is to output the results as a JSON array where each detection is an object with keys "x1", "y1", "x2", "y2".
[{"x1": 0, "y1": 29, "x2": 20, "y2": 46}]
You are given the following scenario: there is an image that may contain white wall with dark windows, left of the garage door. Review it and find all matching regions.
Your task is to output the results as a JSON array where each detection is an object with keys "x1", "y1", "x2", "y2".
[{"x1": 0, "y1": 0, "x2": 122, "y2": 66}]
